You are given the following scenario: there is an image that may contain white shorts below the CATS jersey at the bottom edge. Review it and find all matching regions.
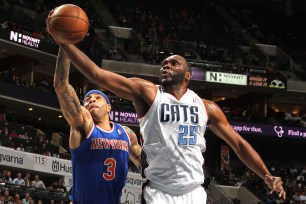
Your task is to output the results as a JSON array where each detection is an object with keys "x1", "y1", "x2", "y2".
[{"x1": 143, "y1": 185, "x2": 207, "y2": 204}]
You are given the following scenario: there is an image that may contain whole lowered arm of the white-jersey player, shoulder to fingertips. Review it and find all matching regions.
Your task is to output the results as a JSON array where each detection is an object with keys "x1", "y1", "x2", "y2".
[{"x1": 203, "y1": 100, "x2": 286, "y2": 199}]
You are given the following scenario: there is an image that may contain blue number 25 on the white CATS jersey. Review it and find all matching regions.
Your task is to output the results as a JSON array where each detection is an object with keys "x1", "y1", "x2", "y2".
[{"x1": 178, "y1": 125, "x2": 198, "y2": 145}]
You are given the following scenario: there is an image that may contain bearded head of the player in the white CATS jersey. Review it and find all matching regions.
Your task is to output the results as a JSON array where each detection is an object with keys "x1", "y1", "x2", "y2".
[{"x1": 160, "y1": 55, "x2": 187, "y2": 86}]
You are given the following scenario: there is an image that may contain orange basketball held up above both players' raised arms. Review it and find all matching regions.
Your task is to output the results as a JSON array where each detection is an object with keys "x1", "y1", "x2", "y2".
[{"x1": 48, "y1": 4, "x2": 89, "y2": 44}]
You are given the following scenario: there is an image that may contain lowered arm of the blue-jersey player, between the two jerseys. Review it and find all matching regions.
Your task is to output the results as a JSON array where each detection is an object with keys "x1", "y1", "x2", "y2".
[{"x1": 123, "y1": 126, "x2": 142, "y2": 168}]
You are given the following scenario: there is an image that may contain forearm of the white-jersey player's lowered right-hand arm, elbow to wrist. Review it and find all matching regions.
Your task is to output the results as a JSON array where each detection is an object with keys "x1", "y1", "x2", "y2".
[{"x1": 236, "y1": 141, "x2": 270, "y2": 179}]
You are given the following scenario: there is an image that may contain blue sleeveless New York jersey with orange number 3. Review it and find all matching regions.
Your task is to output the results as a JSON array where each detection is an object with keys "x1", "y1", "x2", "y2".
[{"x1": 71, "y1": 123, "x2": 130, "y2": 204}]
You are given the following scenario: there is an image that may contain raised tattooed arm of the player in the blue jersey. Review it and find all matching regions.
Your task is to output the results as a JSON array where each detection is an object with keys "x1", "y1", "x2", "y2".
[{"x1": 54, "y1": 49, "x2": 93, "y2": 148}]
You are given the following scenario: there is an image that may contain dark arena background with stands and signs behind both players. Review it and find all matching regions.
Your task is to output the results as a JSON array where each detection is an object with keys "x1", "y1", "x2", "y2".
[{"x1": 0, "y1": 0, "x2": 306, "y2": 203}]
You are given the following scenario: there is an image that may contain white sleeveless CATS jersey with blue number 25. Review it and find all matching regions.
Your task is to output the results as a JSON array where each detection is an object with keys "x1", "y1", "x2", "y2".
[{"x1": 139, "y1": 86, "x2": 207, "y2": 195}]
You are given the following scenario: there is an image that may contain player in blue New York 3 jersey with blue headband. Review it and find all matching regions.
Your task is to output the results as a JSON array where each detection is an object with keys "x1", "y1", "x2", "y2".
[{"x1": 54, "y1": 49, "x2": 141, "y2": 204}]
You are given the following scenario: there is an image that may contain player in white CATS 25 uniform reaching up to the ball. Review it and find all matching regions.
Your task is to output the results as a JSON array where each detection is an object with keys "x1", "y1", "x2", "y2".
[{"x1": 47, "y1": 25, "x2": 286, "y2": 204}]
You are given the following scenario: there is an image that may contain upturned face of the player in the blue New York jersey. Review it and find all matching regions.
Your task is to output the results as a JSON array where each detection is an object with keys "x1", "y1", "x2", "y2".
[{"x1": 84, "y1": 93, "x2": 108, "y2": 115}]
